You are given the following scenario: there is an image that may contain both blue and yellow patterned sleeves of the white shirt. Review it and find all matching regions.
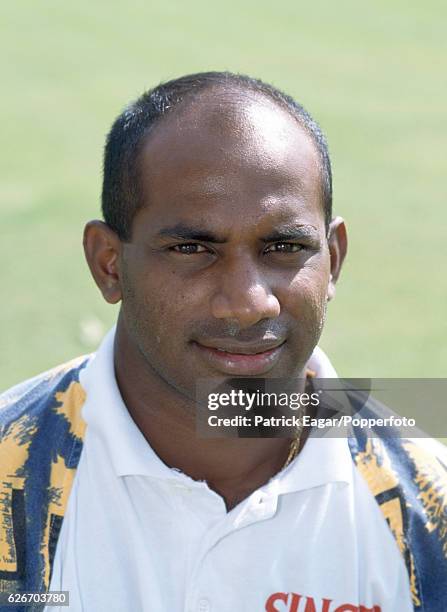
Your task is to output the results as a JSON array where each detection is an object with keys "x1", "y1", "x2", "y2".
[{"x1": 0, "y1": 357, "x2": 447, "y2": 612}]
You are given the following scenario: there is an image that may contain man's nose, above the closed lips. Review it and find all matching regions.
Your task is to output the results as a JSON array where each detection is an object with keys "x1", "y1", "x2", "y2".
[{"x1": 211, "y1": 262, "x2": 281, "y2": 329}]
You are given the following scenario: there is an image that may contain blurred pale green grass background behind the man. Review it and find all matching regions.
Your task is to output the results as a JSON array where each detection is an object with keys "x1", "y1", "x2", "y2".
[{"x1": 0, "y1": 0, "x2": 447, "y2": 388}]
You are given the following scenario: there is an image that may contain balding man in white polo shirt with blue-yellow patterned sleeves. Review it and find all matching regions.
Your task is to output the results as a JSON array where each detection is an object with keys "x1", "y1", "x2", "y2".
[{"x1": 0, "y1": 73, "x2": 447, "y2": 612}]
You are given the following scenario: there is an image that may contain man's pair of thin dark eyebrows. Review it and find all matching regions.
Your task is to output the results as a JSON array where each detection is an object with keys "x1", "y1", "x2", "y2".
[{"x1": 158, "y1": 223, "x2": 319, "y2": 244}]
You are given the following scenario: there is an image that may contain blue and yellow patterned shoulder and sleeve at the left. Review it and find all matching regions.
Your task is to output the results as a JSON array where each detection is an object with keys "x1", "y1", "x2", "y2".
[{"x1": 0, "y1": 356, "x2": 90, "y2": 592}]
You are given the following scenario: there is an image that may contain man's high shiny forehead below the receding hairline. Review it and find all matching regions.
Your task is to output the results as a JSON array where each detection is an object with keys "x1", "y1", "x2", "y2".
[{"x1": 135, "y1": 88, "x2": 324, "y2": 233}]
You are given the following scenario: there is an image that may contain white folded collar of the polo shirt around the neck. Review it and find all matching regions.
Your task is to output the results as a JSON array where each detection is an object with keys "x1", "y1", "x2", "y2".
[{"x1": 80, "y1": 327, "x2": 352, "y2": 494}]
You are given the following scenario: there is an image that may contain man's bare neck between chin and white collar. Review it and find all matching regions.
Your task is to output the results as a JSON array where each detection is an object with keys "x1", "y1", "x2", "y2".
[{"x1": 114, "y1": 323, "x2": 310, "y2": 509}]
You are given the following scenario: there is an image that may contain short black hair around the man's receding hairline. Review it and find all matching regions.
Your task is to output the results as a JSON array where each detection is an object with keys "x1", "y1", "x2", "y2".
[{"x1": 102, "y1": 72, "x2": 332, "y2": 241}]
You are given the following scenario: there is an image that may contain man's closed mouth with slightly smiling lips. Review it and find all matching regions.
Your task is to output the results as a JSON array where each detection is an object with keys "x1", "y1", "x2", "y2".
[{"x1": 192, "y1": 340, "x2": 286, "y2": 376}]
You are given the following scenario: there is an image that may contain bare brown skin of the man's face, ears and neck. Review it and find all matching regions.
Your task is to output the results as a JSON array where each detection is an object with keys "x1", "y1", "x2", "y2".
[{"x1": 84, "y1": 88, "x2": 347, "y2": 509}]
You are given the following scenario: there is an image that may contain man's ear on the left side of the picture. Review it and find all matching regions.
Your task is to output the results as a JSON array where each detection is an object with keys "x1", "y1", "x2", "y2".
[{"x1": 84, "y1": 221, "x2": 121, "y2": 304}]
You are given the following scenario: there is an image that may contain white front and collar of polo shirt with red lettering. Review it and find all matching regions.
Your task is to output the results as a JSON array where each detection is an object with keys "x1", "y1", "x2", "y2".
[{"x1": 47, "y1": 330, "x2": 413, "y2": 612}]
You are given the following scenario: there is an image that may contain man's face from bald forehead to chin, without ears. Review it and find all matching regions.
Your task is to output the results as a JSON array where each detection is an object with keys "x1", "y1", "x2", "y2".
[{"x1": 120, "y1": 89, "x2": 336, "y2": 397}]
